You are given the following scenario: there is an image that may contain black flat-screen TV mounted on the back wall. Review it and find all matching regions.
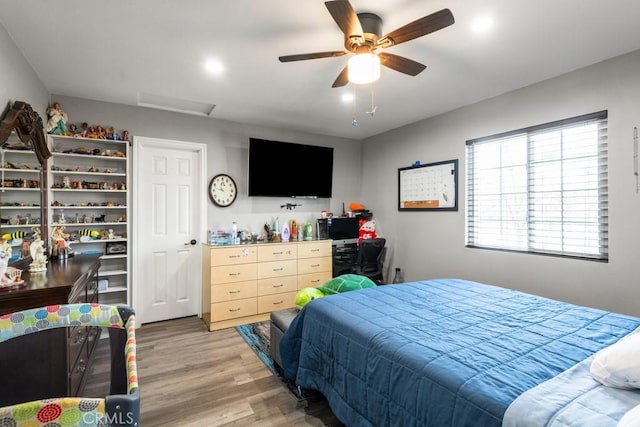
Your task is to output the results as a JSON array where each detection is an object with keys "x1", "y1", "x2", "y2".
[{"x1": 249, "y1": 138, "x2": 333, "y2": 198}]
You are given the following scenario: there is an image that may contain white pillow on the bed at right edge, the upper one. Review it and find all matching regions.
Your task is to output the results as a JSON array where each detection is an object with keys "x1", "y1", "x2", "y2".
[{"x1": 590, "y1": 333, "x2": 640, "y2": 389}]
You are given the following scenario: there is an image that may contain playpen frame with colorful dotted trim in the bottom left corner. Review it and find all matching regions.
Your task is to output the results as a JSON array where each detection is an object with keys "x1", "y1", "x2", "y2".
[{"x1": 0, "y1": 304, "x2": 140, "y2": 427}]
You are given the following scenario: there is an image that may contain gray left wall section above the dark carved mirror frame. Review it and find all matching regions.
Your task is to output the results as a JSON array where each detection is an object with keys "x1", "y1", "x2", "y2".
[{"x1": 0, "y1": 25, "x2": 49, "y2": 125}]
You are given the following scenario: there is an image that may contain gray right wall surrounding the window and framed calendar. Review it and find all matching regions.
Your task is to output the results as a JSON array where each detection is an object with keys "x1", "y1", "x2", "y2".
[{"x1": 363, "y1": 51, "x2": 640, "y2": 315}]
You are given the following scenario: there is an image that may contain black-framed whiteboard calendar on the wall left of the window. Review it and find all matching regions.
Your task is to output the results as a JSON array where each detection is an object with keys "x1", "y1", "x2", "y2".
[{"x1": 398, "y1": 159, "x2": 458, "y2": 211}]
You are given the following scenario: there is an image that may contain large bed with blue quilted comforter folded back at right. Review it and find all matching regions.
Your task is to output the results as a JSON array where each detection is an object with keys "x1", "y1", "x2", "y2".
[{"x1": 280, "y1": 279, "x2": 640, "y2": 426}]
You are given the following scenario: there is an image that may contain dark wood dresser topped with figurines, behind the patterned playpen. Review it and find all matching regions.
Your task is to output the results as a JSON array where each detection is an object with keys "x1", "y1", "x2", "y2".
[{"x1": 0, "y1": 254, "x2": 100, "y2": 406}]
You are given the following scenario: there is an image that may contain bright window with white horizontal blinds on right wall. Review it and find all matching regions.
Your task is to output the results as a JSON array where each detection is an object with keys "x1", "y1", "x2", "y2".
[{"x1": 466, "y1": 111, "x2": 609, "y2": 261}]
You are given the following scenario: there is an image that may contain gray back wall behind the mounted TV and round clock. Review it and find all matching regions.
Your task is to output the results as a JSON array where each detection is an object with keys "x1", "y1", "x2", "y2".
[{"x1": 51, "y1": 95, "x2": 362, "y2": 239}]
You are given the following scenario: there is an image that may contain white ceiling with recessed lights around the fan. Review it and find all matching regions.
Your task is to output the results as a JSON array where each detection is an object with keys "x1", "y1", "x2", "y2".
[{"x1": 0, "y1": 0, "x2": 640, "y2": 139}]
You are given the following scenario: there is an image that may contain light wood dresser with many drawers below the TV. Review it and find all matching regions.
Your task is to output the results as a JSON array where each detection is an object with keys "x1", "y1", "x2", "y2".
[{"x1": 202, "y1": 240, "x2": 332, "y2": 331}]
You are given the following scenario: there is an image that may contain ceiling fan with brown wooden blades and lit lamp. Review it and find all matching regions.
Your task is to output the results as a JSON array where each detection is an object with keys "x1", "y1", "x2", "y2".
[{"x1": 279, "y1": 0, "x2": 455, "y2": 87}]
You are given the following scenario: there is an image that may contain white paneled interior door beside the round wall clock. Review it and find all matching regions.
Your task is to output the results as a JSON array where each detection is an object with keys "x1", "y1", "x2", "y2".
[{"x1": 131, "y1": 137, "x2": 207, "y2": 323}]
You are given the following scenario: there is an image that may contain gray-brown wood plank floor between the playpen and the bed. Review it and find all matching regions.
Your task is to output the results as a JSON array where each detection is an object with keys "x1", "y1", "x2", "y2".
[{"x1": 84, "y1": 317, "x2": 342, "y2": 427}]
